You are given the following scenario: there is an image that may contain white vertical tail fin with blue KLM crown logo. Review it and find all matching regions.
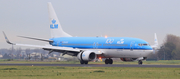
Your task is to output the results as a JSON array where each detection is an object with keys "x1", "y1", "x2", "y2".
[{"x1": 48, "y1": 2, "x2": 71, "y2": 38}]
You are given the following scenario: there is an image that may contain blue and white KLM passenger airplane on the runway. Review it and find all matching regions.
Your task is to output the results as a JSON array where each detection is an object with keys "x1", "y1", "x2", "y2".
[{"x1": 3, "y1": 2, "x2": 158, "y2": 65}]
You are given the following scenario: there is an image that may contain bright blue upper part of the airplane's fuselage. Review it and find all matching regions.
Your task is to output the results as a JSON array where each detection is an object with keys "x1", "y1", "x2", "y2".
[{"x1": 50, "y1": 37, "x2": 152, "y2": 50}]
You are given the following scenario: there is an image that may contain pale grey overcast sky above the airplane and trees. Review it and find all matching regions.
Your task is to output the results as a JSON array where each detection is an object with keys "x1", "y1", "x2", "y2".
[{"x1": 0, "y1": 0, "x2": 180, "y2": 49}]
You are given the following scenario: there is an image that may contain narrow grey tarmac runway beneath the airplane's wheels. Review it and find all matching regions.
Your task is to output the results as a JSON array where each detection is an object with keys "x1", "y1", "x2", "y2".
[{"x1": 0, "y1": 63, "x2": 180, "y2": 68}]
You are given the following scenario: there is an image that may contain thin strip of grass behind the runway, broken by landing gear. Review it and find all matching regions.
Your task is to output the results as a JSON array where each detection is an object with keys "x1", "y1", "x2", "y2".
[{"x1": 0, "y1": 60, "x2": 180, "y2": 65}]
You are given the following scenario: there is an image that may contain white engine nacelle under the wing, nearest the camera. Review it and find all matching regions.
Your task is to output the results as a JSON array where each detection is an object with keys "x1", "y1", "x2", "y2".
[{"x1": 77, "y1": 51, "x2": 96, "y2": 61}]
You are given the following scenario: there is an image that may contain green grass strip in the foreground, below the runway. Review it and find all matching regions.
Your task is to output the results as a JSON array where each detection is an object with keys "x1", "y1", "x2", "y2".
[{"x1": 0, "y1": 66, "x2": 180, "y2": 79}]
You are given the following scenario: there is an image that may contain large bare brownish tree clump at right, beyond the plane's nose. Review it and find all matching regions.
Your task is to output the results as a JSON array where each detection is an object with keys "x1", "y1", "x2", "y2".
[{"x1": 149, "y1": 34, "x2": 180, "y2": 60}]
